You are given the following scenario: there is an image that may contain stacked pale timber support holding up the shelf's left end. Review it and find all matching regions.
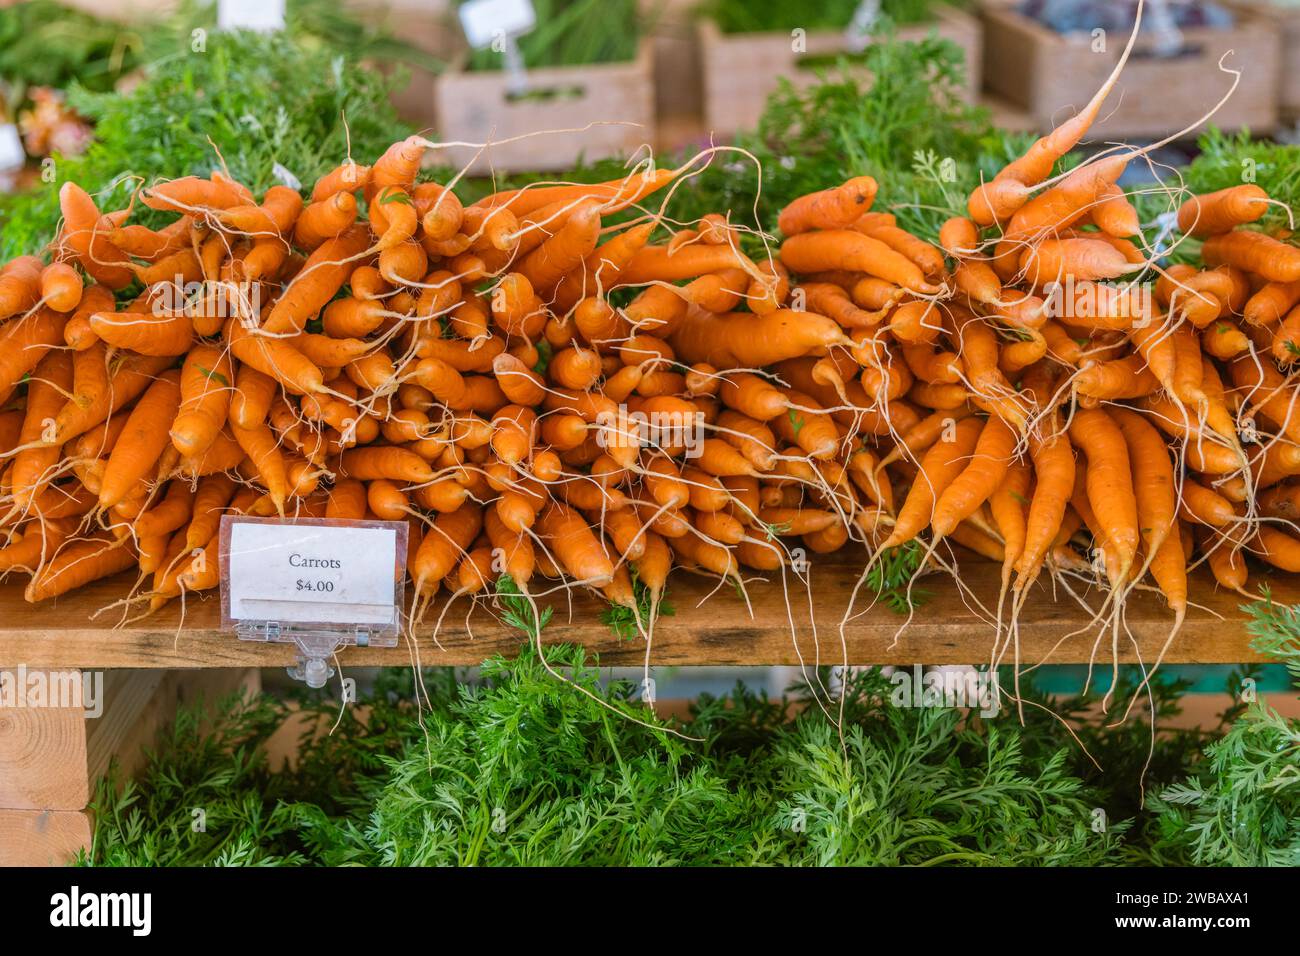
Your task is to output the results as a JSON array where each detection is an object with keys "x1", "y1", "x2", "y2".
[{"x1": 0, "y1": 665, "x2": 261, "y2": 866}]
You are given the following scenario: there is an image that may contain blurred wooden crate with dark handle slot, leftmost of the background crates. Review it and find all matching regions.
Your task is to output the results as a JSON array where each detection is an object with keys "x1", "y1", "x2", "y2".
[{"x1": 437, "y1": 39, "x2": 655, "y2": 174}]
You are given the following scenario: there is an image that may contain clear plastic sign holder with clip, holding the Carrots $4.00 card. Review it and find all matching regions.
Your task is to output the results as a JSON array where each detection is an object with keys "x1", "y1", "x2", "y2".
[{"x1": 220, "y1": 515, "x2": 408, "y2": 688}]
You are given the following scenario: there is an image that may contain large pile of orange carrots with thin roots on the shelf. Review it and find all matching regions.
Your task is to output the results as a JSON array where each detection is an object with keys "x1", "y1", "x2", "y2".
[{"x1": 0, "y1": 1, "x2": 1300, "y2": 671}]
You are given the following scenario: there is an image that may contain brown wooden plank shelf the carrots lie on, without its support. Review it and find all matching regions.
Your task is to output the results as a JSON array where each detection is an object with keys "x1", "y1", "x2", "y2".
[{"x1": 0, "y1": 554, "x2": 1284, "y2": 669}]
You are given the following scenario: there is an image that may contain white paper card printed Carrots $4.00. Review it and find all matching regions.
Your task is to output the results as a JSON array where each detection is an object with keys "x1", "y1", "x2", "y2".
[{"x1": 226, "y1": 522, "x2": 398, "y2": 624}]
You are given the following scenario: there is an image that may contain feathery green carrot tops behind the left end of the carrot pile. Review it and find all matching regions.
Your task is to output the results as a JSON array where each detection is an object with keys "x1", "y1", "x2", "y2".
[{"x1": 0, "y1": 31, "x2": 410, "y2": 260}]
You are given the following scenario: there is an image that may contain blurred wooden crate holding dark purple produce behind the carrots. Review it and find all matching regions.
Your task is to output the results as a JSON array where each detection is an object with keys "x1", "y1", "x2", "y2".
[{"x1": 983, "y1": 1, "x2": 1281, "y2": 140}]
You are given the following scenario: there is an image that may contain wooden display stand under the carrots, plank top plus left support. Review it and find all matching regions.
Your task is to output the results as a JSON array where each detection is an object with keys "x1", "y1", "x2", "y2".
[{"x1": 0, "y1": 554, "x2": 1300, "y2": 865}]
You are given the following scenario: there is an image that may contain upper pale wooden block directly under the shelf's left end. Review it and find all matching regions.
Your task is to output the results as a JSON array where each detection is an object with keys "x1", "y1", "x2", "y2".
[{"x1": 0, "y1": 667, "x2": 90, "y2": 810}]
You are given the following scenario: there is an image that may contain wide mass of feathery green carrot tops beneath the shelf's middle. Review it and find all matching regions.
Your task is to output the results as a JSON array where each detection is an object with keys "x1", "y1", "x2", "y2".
[{"x1": 87, "y1": 646, "x2": 1125, "y2": 865}]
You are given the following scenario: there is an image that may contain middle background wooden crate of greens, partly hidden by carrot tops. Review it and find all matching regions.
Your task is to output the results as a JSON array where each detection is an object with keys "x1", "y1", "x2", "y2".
[{"x1": 698, "y1": 5, "x2": 982, "y2": 135}]
